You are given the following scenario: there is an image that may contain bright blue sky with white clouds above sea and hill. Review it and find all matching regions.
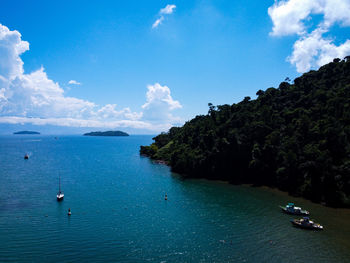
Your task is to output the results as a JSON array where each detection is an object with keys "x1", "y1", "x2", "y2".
[{"x1": 0, "y1": 0, "x2": 350, "y2": 134}]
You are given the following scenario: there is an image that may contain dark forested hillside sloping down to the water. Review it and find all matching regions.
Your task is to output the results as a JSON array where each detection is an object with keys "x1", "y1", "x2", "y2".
[{"x1": 140, "y1": 57, "x2": 350, "y2": 206}]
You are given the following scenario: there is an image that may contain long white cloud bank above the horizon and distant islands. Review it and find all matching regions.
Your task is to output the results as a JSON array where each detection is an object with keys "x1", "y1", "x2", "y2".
[{"x1": 0, "y1": 24, "x2": 181, "y2": 131}]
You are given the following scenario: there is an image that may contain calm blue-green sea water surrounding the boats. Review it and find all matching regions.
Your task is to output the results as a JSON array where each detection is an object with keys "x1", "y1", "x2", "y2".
[{"x1": 0, "y1": 135, "x2": 350, "y2": 263}]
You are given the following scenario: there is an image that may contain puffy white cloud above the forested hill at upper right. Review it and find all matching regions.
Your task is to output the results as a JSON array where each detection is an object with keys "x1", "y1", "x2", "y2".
[{"x1": 268, "y1": 0, "x2": 350, "y2": 72}]
